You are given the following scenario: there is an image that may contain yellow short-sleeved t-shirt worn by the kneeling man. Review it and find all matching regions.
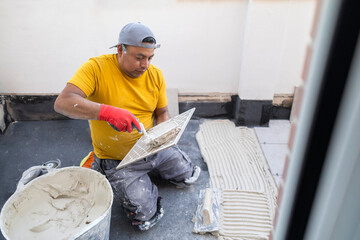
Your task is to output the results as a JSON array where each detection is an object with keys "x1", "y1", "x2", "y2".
[{"x1": 69, "y1": 54, "x2": 167, "y2": 160}]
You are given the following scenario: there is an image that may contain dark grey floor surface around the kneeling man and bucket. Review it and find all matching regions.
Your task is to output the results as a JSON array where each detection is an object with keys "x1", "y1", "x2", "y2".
[{"x1": 0, "y1": 120, "x2": 216, "y2": 240}]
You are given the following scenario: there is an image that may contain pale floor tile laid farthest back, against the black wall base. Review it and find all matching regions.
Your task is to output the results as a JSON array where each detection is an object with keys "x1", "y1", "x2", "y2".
[{"x1": 255, "y1": 120, "x2": 290, "y2": 144}]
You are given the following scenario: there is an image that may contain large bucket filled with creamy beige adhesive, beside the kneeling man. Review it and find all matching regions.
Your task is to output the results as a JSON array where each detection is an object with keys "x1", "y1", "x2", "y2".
[{"x1": 0, "y1": 167, "x2": 113, "y2": 240}]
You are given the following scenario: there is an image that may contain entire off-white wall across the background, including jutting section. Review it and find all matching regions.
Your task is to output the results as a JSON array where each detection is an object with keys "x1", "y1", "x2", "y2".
[{"x1": 0, "y1": 0, "x2": 313, "y2": 99}]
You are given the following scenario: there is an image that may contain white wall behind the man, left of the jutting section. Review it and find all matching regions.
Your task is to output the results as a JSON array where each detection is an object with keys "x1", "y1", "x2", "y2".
[{"x1": 0, "y1": 0, "x2": 247, "y2": 93}]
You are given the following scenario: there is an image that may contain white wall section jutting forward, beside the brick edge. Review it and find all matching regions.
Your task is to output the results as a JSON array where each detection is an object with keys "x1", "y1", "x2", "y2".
[{"x1": 238, "y1": 0, "x2": 315, "y2": 100}]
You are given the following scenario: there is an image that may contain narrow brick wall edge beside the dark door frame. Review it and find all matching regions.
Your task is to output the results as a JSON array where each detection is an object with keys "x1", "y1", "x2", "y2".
[{"x1": 269, "y1": 0, "x2": 322, "y2": 240}]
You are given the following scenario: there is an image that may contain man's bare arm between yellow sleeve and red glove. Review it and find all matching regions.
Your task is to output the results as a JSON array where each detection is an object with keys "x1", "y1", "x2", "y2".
[{"x1": 54, "y1": 83, "x2": 100, "y2": 120}]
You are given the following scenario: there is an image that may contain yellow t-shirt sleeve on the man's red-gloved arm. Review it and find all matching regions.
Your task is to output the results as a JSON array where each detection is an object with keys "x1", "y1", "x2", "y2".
[{"x1": 68, "y1": 59, "x2": 97, "y2": 97}]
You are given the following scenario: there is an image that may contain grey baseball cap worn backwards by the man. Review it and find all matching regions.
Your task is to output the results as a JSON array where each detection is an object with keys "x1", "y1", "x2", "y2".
[{"x1": 110, "y1": 22, "x2": 160, "y2": 48}]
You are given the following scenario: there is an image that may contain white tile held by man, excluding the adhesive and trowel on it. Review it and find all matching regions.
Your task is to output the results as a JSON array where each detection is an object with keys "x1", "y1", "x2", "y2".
[{"x1": 116, "y1": 108, "x2": 195, "y2": 169}]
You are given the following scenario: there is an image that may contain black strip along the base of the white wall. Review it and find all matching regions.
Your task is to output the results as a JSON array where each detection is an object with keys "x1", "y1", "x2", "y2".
[{"x1": 0, "y1": 93, "x2": 293, "y2": 132}]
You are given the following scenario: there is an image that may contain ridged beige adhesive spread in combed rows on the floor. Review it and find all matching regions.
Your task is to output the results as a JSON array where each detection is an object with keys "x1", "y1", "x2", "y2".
[{"x1": 196, "y1": 120, "x2": 277, "y2": 239}]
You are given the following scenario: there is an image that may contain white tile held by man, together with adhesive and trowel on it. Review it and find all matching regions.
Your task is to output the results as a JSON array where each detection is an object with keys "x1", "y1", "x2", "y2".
[{"x1": 116, "y1": 108, "x2": 195, "y2": 169}]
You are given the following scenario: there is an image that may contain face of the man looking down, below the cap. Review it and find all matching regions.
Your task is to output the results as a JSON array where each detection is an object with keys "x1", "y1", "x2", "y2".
[{"x1": 118, "y1": 45, "x2": 154, "y2": 78}]
